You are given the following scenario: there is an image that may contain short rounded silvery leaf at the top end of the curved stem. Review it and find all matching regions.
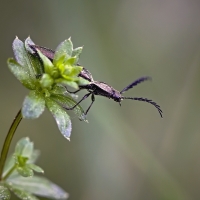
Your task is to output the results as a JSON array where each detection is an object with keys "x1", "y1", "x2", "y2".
[{"x1": 22, "y1": 91, "x2": 45, "y2": 119}]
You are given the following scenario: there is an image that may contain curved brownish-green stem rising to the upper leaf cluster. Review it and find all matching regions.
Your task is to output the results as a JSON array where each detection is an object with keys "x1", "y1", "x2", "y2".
[{"x1": 0, "y1": 110, "x2": 22, "y2": 181}]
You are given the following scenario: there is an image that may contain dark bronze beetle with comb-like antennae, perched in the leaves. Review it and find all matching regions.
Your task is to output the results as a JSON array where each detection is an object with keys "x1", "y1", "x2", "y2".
[{"x1": 30, "y1": 45, "x2": 162, "y2": 117}]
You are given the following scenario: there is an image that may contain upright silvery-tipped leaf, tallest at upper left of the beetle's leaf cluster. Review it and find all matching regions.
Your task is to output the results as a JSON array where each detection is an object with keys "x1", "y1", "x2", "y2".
[{"x1": 13, "y1": 37, "x2": 35, "y2": 80}]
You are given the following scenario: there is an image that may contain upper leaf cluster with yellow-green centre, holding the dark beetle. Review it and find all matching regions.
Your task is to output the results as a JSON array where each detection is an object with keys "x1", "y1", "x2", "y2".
[{"x1": 8, "y1": 38, "x2": 87, "y2": 140}]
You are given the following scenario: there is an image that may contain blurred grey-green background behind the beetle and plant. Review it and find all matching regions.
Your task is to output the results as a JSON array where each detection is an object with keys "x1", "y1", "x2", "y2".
[{"x1": 0, "y1": 0, "x2": 200, "y2": 200}]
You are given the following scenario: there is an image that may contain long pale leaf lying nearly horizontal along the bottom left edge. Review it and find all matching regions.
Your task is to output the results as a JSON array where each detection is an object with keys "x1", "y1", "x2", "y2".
[{"x1": 10, "y1": 176, "x2": 69, "y2": 199}]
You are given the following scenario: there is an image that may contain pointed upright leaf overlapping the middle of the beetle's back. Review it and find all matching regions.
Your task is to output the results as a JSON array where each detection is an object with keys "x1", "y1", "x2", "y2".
[{"x1": 53, "y1": 38, "x2": 73, "y2": 65}]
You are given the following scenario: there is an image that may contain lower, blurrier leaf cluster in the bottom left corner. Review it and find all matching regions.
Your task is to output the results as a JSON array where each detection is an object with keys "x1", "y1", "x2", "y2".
[{"x1": 0, "y1": 138, "x2": 68, "y2": 200}]
